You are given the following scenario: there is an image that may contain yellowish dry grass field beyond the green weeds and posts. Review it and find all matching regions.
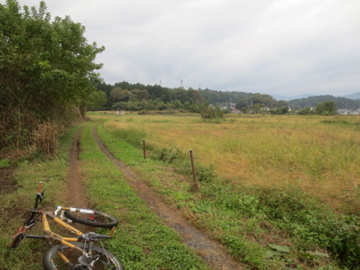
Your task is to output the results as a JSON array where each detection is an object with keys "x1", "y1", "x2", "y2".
[{"x1": 91, "y1": 115, "x2": 360, "y2": 213}]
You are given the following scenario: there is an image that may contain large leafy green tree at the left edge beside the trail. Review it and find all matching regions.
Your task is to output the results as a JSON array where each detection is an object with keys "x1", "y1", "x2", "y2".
[{"x1": 0, "y1": 0, "x2": 104, "y2": 147}]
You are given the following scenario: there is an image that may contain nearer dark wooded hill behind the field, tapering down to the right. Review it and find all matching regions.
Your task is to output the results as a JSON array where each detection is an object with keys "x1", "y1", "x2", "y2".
[{"x1": 94, "y1": 82, "x2": 288, "y2": 112}]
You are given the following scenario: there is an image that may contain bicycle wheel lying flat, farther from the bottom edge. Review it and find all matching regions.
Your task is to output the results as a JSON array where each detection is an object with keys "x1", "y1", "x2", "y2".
[{"x1": 64, "y1": 208, "x2": 119, "y2": 228}]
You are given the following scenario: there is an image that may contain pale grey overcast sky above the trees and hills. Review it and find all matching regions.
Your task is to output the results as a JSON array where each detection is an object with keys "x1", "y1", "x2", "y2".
[{"x1": 0, "y1": 0, "x2": 360, "y2": 96}]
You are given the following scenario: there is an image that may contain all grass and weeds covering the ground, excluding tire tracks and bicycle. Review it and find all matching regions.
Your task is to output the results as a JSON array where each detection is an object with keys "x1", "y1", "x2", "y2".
[{"x1": 0, "y1": 114, "x2": 360, "y2": 270}]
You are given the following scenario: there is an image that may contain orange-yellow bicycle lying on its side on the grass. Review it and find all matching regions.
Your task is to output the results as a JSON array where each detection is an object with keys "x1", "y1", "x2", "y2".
[{"x1": 10, "y1": 182, "x2": 123, "y2": 270}]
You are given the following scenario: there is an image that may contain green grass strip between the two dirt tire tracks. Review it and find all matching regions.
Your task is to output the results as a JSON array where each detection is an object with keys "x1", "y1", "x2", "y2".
[{"x1": 80, "y1": 125, "x2": 208, "y2": 269}]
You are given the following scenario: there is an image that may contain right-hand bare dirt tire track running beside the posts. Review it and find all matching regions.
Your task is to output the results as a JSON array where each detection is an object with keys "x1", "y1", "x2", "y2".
[{"x1": 92, "y1": 126, "x2": 245, "y2": 270}]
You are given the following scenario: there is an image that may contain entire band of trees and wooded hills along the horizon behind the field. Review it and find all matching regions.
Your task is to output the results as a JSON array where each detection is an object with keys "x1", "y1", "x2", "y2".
[{"x1": 93, "y1": 81, "x2": 360, "y2": 114}]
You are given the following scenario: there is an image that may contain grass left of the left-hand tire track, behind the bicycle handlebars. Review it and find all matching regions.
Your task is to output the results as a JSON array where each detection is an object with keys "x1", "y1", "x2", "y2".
[{"x1": 0, "y1": 125, "x2": 76, "y2": 270}]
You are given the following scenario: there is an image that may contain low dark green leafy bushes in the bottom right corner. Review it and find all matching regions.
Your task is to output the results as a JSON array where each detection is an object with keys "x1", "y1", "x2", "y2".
[{"x1": 259, "y1": 190, "x2": 360, "y2": 269}]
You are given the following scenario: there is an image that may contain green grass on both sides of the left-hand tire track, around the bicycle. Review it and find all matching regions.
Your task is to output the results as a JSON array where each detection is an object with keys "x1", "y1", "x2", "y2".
[{"x1": 0, "y1": 122, "x2": 209, "y2": 270}]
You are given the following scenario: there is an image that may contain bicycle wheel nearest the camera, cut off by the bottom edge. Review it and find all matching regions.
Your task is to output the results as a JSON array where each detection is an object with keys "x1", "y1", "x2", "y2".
[{"x1": 43, "y1": 242, "x2": 123, "y2": 270}]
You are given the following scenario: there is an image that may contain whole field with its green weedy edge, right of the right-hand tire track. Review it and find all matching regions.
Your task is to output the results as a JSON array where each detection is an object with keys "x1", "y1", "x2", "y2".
[{"x1": 93, "y1": 115, "x2": 360, "y2": 269}]
